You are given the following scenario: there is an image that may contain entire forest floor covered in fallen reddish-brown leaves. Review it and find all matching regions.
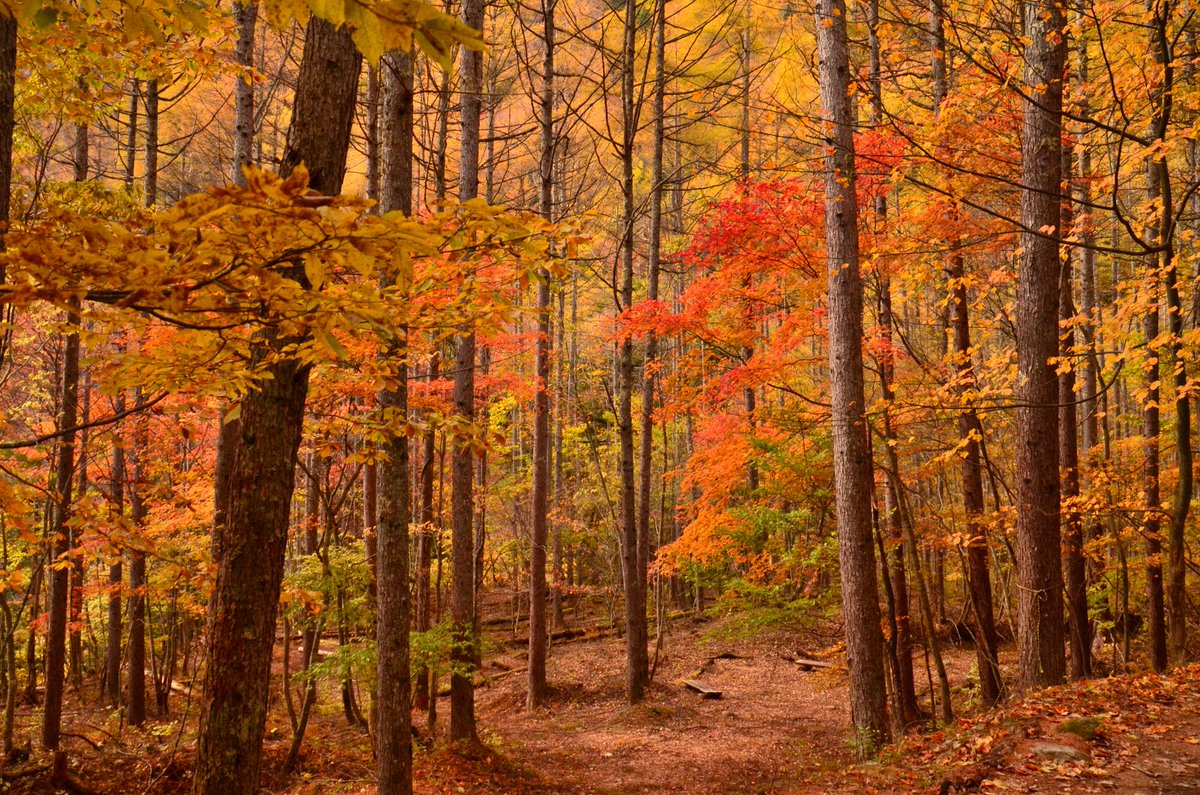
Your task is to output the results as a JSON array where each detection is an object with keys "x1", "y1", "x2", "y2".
[{"x1": 0, "y1": 600, "x2": 1200, "y2": 795}]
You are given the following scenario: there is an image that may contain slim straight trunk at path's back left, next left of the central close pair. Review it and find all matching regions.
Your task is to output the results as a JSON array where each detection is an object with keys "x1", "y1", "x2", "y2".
[{"x1": 526, "y1": 0, "x2": 557, "y2": 710}]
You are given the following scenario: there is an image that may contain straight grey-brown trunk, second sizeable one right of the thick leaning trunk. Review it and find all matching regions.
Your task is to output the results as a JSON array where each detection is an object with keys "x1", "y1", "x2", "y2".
[{"x1": 450, "y1": 0, "x2": 486, "y2": 742}]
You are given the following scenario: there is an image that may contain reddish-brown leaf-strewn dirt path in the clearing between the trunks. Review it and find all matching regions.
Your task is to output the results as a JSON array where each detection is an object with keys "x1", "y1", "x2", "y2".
[{"x1": 478, "y1": 627, "x2": 852, "y2": 794}]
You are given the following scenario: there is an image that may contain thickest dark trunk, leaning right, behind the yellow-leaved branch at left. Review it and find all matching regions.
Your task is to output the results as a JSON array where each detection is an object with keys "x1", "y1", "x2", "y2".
[{"x1": 193, "y1": 18, "x2": 361, "y2": 795}]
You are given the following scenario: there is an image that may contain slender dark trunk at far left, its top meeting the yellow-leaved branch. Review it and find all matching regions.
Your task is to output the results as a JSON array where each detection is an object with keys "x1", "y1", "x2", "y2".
[{"x1": 42, "y1": 299, "x2": 79, "y2": 748}]
